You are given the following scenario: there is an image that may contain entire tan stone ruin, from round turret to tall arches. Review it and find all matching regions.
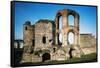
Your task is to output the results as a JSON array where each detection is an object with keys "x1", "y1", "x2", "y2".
[{"x1": 21, "y1": 9, "x2": 95, "y2": 63}]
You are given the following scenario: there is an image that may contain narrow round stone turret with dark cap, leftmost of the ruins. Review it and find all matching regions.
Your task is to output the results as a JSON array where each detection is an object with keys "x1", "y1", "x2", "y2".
[{"x1": 22, "y1": 21, "x2": 35, "y2": 62}]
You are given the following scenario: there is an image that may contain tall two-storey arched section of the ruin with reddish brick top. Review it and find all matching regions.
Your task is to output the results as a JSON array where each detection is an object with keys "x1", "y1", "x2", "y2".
[{"x1": 55, "y1": 9, "x2": 81, "y2": 56}]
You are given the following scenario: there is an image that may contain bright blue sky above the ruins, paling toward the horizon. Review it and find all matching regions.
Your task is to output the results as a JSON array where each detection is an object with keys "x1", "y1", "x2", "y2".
[{"x1": 14, "y1": 2, "x2": 97, "y2": 39}]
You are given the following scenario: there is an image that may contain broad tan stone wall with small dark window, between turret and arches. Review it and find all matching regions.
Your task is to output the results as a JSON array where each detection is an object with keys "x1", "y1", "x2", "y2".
[{"x1": 34, "y1": 21, "x2": 54, "y2": 51}]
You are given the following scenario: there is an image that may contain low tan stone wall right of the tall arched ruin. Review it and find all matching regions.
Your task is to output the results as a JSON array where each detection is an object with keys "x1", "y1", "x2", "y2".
[{"x1": 80, "y1": 34, "x2": 97, "y2": 54}]
